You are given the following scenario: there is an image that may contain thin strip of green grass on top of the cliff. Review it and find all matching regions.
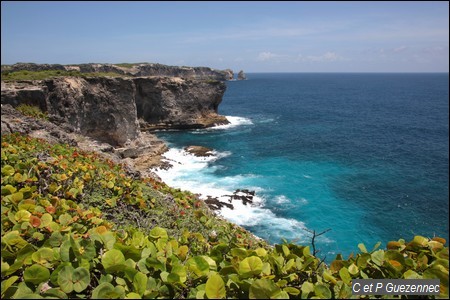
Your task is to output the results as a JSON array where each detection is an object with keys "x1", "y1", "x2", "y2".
[{"x1": 2, "y1": 70, "x2": 125, "y2": 81}]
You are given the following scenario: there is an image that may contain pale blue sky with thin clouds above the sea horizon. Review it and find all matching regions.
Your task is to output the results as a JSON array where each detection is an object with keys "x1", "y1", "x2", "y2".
[{"x1": 1, "y1": 1, "x2": 449, "y2": 72}]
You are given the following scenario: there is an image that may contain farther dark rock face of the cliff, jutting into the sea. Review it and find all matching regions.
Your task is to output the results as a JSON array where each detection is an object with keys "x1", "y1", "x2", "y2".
[{"x1": 134, "y1": 77, "x2": 228, "y2": 129}]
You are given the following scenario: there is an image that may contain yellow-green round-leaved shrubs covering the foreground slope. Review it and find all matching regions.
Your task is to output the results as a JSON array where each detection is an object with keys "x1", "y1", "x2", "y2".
[{"x1": 1, "y1": 134, "x2": 449, "y2": 299}]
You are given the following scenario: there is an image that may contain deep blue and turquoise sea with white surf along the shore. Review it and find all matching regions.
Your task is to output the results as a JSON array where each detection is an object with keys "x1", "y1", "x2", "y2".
[{"x1": 153, "y1": 73, "x2": 449, "y2": 261}]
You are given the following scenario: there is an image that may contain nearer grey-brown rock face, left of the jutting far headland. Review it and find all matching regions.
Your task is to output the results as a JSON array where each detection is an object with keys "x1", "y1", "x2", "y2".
[{"x1": 46, "y1": 77, "x2": 139, "y2": 145}]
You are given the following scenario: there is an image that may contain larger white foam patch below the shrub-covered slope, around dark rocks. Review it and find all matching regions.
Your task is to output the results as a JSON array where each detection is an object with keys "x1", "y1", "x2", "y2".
[{"x1": 154, "y1": 148, "x2": 307, "y2": 242}]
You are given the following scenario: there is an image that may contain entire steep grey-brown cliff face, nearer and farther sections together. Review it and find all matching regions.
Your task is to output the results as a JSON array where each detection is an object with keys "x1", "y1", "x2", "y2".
[{"x1": 1, "y1": 77, "x2": 228, "y2": 146}]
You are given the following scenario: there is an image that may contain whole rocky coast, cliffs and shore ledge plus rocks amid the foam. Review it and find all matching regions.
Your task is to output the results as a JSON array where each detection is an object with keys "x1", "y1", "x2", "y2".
[{"x1": 1, "y1": 63, "x2": 254, "y2": 210}]
